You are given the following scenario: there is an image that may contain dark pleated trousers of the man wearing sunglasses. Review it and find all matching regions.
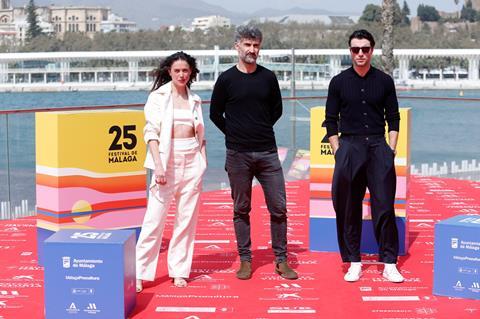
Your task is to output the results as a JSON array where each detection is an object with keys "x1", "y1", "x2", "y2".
[{"x1": 332, "y1": 135, "x2": 398, "y2": 263}]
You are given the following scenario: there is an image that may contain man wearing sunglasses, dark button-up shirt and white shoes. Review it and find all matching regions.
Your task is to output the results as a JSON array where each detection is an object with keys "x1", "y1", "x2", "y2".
[{"x1": 325, "y1": 30, "x2": 404, "y2": 282}]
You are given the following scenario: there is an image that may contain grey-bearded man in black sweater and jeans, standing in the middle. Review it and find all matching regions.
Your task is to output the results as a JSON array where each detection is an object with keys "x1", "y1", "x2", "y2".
[{"x1": 210, "y1": 26, "x2": 298, "y2": 279}]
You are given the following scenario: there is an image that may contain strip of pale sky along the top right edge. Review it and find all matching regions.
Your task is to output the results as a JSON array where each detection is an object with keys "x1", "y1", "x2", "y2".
[{"x1": 204, "y1": 0, "x2": 463, "y2": 14}]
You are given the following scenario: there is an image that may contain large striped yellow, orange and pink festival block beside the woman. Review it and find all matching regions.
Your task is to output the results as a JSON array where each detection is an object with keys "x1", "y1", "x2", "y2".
[{"x1": 36, "y1": 110, "x2": 146, "y2": 258}]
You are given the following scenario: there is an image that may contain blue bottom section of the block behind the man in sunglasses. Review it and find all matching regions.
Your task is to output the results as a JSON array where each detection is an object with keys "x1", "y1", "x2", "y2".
[{"x1": 310, "y1": 217, "x2": 408, "y2": 256}]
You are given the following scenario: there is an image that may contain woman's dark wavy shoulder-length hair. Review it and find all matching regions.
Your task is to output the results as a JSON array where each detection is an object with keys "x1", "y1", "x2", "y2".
[{"x1": 152, "y1": 51, "x2": 200, "y2": 91}]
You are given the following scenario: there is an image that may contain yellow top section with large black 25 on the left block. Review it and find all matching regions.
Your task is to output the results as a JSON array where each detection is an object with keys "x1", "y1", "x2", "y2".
[{"x1": 35, "y1": 110, "x2": 146, "y2": 173}]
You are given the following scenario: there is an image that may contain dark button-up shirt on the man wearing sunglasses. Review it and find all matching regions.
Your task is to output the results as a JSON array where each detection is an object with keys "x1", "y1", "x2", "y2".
[{"x1": 324, "y1": 66, "x2": 400, "y2": 137}]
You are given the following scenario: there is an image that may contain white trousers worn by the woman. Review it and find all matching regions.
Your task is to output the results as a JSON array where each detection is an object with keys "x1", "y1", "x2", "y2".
[{"x1": 136, "y1": 148, "x2": 205, "y2": 281}]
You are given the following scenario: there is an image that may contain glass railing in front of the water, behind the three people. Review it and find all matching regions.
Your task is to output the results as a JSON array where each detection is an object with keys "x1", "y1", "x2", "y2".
[{"x1": 0, "y1": 91, "x2": 480, "y2": 219}]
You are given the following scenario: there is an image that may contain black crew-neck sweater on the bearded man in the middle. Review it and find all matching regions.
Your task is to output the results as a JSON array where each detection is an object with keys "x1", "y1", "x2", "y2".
[{"x1": 210, "y1": 65, "x2": 282, "y2": 152}]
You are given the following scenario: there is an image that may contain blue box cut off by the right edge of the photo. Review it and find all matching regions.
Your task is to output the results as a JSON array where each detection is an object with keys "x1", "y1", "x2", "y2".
[{"x1": 433, "y1": 215, "x2": 480, "y2": 299}]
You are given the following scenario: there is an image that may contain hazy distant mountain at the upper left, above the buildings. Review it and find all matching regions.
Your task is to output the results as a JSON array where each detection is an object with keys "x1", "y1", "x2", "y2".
[{"x1": 30, "y1": 0, "x2": 244, "y2": 29}]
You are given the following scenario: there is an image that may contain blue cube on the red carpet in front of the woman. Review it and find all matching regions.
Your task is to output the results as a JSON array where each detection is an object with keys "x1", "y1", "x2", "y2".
[{"x1": 43, "y1": 229, "x2": 136, "y2": 319}]
